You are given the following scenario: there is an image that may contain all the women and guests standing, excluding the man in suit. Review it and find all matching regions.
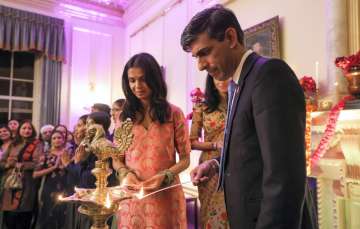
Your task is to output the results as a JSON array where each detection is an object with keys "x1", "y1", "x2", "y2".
[{"x1": 0, "y1": 53, "x2": 228, "y2": 229}]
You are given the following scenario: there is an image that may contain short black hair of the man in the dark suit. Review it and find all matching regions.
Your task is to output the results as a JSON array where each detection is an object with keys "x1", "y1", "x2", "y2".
[{"x1": 181, "y1": 5, "x2": 244, "y2": 52}]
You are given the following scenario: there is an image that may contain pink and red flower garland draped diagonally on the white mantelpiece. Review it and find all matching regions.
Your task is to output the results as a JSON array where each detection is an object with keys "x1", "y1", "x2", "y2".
[{"x1": 310, "y1": 95, "x2": 354, "y2": 166}]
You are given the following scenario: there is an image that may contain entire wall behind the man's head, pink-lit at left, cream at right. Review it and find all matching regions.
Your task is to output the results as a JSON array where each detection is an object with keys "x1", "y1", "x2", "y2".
[{"x1": 126, "y1": 0, "x2": 326, "y2": 113}]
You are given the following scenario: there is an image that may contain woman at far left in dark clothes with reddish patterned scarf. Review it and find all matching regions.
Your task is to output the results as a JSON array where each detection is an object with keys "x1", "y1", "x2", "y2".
[{"x1": 0, "y1": 121, "x2": 43, "y2": 229}]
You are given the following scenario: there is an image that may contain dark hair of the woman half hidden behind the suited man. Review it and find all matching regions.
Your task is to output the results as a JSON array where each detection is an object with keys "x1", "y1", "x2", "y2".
[{"x1": 204, "y1": 75, "x2": 221, "y2": 113}]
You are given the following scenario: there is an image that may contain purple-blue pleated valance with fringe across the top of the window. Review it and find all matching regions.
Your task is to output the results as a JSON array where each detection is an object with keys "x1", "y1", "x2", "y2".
[{"x1": 0, "y1": 5, "x2": 65, "y2": 62}]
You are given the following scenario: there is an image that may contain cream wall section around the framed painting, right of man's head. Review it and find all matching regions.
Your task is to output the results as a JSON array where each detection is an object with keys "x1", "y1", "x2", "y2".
[{"x1": 228, "y1": 0, "x2": 326, "y2": 85}]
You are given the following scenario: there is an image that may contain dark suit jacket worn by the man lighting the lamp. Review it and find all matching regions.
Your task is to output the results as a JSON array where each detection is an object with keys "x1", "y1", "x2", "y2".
[{"x1": 219, "y1": 53, "x2": 306, "y2": 229}]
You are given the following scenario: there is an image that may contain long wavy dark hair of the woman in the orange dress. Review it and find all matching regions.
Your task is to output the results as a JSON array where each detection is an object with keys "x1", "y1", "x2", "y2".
[{"x1": 121, "y1": 53, "x2": 171, "y2": 124}]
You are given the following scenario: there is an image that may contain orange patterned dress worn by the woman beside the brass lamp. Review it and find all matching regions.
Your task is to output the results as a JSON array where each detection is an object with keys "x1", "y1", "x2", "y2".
[{"x1": 118, "y1": 105, "x2": 191, "y2": 229}]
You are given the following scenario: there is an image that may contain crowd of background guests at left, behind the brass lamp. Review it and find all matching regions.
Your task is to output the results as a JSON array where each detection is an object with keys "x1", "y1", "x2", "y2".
[{"x1": 0, "y1": 102, "x2": 125, "y2": 229}]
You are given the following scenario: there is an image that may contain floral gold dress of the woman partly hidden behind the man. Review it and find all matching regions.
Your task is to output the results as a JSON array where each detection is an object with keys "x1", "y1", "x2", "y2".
[{"x1": 190, "y1": 102, "x2": 229, "y2": 229}]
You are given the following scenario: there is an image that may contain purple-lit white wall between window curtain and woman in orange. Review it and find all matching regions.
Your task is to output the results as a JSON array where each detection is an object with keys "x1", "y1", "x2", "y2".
[{"x1": 61, "y1": 19, "x2": 124, "y2": 128}]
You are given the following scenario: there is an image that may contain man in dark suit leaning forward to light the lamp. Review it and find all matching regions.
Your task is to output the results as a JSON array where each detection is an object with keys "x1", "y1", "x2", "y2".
[{"x1": 181, "y1": 5, "x2": 306, "y2": 229}]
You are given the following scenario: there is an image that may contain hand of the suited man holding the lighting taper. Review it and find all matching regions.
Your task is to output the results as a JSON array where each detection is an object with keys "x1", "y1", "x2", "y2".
[{"x1": 190, "y1": 159, "x2": 219, "y2": 186}]
